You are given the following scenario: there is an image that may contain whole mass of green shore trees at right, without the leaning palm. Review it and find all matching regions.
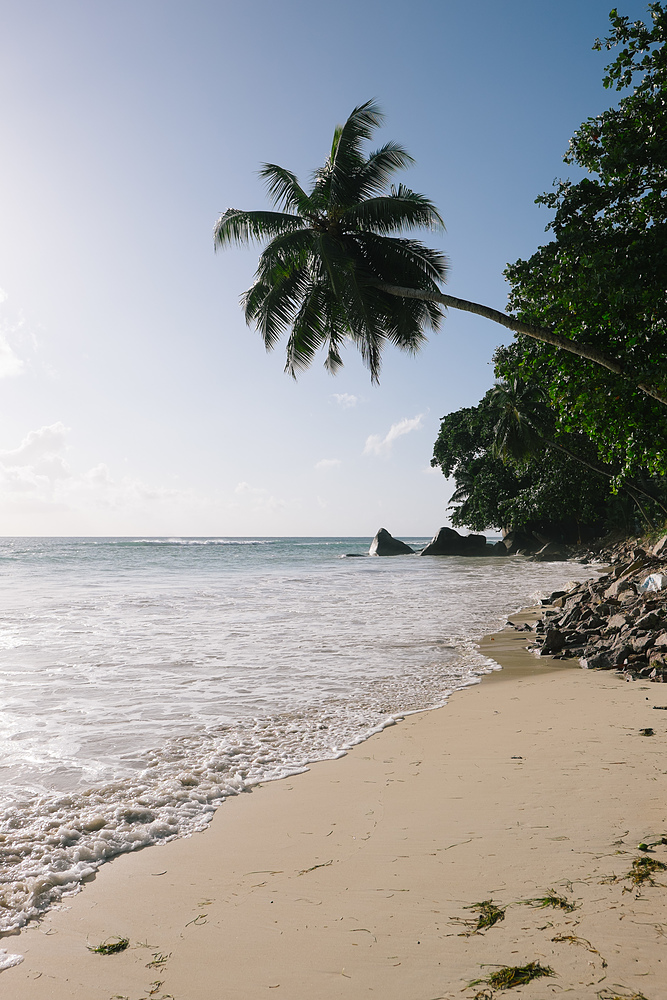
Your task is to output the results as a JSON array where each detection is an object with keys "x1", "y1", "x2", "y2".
[{"x1": 432, "y1": 3, "x2": 667, "y2": 541}]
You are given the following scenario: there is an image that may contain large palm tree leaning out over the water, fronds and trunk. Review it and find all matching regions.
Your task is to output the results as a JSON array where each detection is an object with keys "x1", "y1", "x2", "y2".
[{"x1": 214, "y1": 101, "x2": 667, "y2": 405}]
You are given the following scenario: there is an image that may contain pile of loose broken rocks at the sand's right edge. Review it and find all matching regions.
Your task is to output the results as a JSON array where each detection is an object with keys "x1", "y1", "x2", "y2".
[{"x1": 510, "y1": 535, "x2": 667, "y2": 683}]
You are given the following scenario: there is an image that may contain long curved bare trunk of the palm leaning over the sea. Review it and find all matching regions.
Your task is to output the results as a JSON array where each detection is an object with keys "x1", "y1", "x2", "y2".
[{"x1": 376, "y1": 282, "x2": 667, "y2": 406}]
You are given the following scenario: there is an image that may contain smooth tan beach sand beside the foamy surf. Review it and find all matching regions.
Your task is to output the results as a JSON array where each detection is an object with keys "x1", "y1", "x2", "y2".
[{"x1": 0, "y1": 620, "x2": 667, "y2": 1000}]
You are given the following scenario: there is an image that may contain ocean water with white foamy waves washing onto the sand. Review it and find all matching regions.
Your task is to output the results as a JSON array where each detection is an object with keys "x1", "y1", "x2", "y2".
[{"x1": 0, "y1": 538, "x2": 574, "y2": 936}]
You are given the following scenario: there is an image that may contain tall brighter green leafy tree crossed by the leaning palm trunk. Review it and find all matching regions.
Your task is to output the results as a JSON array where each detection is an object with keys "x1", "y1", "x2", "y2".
[{"x1": 506, "y1": 3, "x2": 667, "y2": 476}]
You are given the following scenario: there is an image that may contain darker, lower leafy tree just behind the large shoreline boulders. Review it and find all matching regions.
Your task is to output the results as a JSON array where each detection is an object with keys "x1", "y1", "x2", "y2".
[{"x1": 431, "y1": 382, "x2": 656, "y2": 541}]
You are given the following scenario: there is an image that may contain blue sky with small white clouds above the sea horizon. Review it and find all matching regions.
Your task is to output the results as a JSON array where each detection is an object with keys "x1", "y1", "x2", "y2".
[{"x1": 0, "y1": 0, "x2": 646, "y2": 535}]
